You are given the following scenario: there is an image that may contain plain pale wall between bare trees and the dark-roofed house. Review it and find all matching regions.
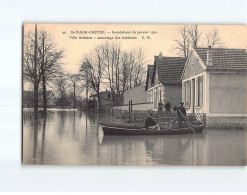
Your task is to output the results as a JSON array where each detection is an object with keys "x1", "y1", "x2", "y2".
[{"x1": 124, "y1": 85, "x2": 148, "y2": 104}]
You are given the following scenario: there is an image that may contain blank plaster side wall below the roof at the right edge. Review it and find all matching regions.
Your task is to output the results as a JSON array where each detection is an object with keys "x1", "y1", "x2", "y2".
[{"x1": 209, "y1": 72, "x2": 247, "y2": 114}]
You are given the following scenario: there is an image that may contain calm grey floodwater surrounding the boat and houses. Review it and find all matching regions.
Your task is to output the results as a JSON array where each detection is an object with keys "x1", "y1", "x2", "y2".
[{"x1": 23, "y1": 109, "x2": 247, "y2": 166}]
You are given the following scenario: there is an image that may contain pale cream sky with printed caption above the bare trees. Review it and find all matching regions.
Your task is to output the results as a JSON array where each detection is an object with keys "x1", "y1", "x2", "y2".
[{"x1": 24, "y1": 24, "x2": 247, "y2": 73}]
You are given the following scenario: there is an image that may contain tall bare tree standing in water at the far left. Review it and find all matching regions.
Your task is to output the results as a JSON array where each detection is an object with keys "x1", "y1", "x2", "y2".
[{"x1": 23, "y1": 27, "x2": 63, "y2": 112}]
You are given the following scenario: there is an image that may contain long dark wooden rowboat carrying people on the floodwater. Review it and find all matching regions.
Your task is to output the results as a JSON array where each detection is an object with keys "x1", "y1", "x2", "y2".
[{"x1": 101, "y1": 123, "x2": 205, "y2": 135}]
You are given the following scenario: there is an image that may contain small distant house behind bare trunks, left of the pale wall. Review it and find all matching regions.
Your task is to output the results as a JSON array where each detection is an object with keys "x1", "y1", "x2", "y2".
[{"x1": 89, "y1": 90, "x2": 115, "y2": 110}]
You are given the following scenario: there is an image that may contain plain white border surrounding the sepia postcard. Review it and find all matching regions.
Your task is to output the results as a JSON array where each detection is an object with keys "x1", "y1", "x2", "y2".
[{"x1": 0, "y1": 0, "x2": 247, "y2": 191}]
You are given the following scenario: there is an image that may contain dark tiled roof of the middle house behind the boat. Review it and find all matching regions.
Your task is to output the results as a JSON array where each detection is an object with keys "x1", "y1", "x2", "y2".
[{"x1": 152, "y1": 56, "x2": 186, "y2": 84}]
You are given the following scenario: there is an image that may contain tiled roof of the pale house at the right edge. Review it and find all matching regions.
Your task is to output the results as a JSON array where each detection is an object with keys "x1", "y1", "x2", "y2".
[{"x1": 194, "y1": 47, "x2": 247, "y2": 70}]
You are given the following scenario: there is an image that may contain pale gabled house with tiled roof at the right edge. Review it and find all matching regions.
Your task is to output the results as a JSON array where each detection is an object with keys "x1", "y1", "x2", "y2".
[{"x1": 181, "y1": 47, "x2": 247, "y2": 127}]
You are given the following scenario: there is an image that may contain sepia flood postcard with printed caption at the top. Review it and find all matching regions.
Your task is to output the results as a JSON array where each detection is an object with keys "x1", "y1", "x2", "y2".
[{"x1": 22, "y1": 23, "x2": 247, "y2": 166}]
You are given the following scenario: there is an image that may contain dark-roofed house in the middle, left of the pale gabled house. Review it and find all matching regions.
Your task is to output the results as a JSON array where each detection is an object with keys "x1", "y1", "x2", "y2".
[{"x1": 146, "y1": 53, "x2": 186, "y2": 109}]
